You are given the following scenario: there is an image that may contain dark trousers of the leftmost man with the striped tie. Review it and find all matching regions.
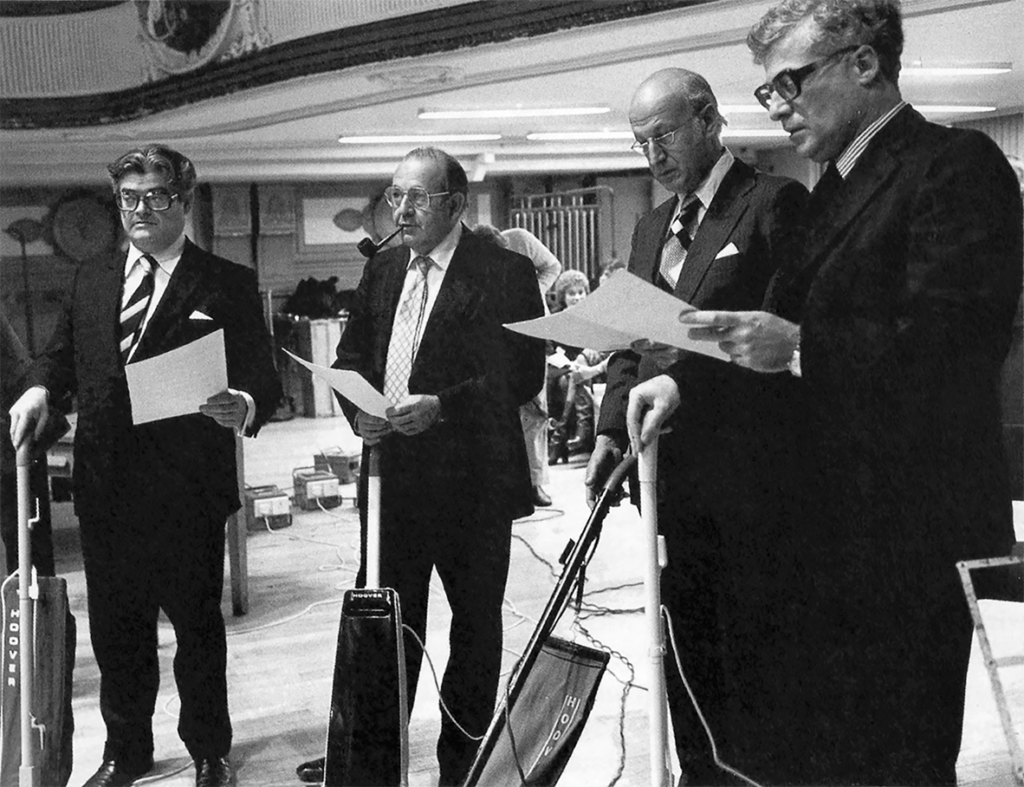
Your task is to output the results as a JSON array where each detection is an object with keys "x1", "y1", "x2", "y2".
[{"x1": 81, "y1": 500, "x2": 231, "y2": 770}]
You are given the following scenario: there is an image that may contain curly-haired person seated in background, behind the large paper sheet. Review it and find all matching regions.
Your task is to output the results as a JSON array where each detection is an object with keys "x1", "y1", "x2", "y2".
[{"x1": 548, "y1": 270, "x2": 607, "y2": 465}]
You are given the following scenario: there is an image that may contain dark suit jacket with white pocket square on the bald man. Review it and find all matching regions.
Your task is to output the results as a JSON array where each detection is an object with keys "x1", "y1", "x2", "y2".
[{"x1": 598, "y1": 161, "x2": 807, "y2": 504}]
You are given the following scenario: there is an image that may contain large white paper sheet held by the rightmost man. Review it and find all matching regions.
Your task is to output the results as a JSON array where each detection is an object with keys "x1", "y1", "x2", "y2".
[{"x1": 505, "y1": 270, "x2": 729, "y2": 361}]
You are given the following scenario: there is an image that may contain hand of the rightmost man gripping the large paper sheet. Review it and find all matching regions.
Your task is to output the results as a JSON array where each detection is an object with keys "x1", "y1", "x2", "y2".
[{"x1": 679, "y1": 311, "x2": 800, "y2": 371}]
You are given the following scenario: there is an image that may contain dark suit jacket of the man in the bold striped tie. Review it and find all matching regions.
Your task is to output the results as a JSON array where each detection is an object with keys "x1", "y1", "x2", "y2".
[{"x1": 28, "y1": 241, "x2": 281, "y2": 518}]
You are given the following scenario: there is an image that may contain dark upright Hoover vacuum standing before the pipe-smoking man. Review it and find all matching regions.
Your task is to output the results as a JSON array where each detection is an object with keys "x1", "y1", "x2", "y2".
[{"x1": 324, "y1": 447, "x2": 409, "y2": 787}]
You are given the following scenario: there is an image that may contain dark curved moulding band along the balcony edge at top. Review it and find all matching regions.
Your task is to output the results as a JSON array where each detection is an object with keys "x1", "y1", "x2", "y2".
[{"x1": 0, "y1": 0, "x2": 713, "y2": 129}]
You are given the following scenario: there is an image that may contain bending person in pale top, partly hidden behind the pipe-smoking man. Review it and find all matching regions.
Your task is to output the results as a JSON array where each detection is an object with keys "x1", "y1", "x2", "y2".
[{"x1": 502, "y1": 227, "x2": 562, "y2": 506}]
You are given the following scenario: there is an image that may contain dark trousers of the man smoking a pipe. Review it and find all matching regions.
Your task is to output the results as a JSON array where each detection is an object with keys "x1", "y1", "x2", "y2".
[{"x1": 364, "y1": 489, "x2": 512, "y2": 785}]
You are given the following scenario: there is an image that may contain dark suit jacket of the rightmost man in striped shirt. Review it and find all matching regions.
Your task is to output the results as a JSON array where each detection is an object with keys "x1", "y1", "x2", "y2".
[{"x1": 767, "y1": 107, "x2": 1022, "y2": 560}]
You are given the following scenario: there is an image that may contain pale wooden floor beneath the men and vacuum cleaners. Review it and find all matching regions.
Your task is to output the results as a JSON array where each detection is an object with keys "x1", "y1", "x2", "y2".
[{"x1": 28, "y1": 419, "x2": 1024, "y2": 787}]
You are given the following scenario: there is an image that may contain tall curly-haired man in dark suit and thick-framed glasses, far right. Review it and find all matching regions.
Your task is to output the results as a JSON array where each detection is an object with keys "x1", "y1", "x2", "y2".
[{"x1": 663, "y1": 0, "x2": 1022, "y2": 787}]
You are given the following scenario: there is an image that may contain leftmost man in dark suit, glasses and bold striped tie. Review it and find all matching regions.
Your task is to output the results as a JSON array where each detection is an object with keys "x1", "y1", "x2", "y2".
[{"x1": 10, "y1": 145, "x2": 281, "y2": 787}]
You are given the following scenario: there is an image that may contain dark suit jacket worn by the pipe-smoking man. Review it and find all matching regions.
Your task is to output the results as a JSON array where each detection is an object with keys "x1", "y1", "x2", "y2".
[{"x1": 334, "y1": 227, "x2": 544, "y2": 519}]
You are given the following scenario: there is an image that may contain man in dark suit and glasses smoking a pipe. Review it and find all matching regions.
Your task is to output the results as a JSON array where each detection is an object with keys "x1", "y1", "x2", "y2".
[{"x1": 334, "y1": 148, "x2": 544, "y2": 787}]
